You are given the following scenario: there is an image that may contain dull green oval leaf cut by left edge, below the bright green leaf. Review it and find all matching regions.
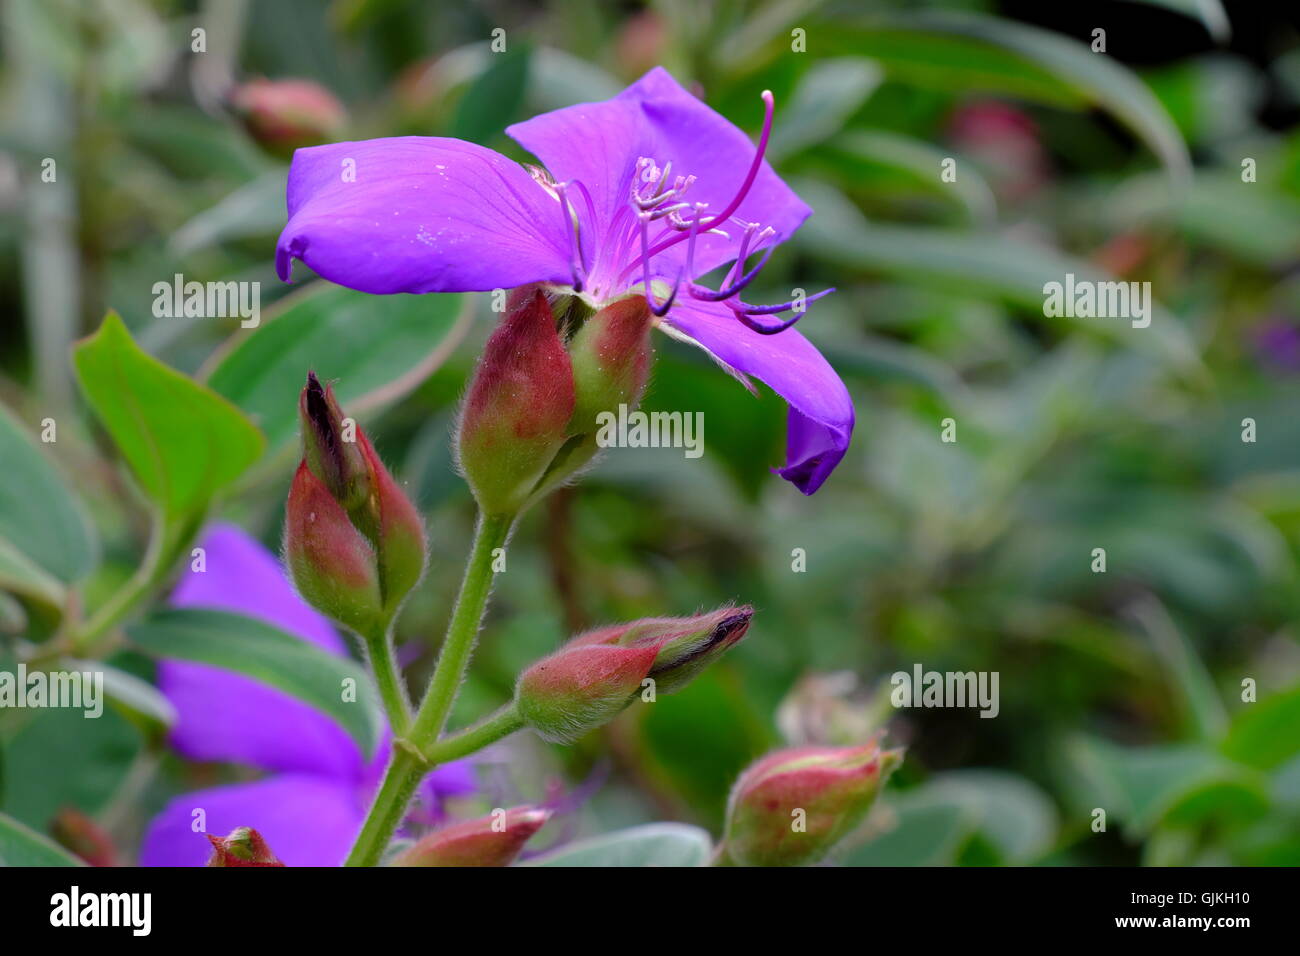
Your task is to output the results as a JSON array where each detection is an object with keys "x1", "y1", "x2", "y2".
[{"x1": 0, "y1": 406, "x2": 96, "y2": 583}]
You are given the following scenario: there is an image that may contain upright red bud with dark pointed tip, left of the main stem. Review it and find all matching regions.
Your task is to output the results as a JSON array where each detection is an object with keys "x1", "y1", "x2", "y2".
[{"x1": 285, "y1": 375, "x2": 425, "y2": 635}]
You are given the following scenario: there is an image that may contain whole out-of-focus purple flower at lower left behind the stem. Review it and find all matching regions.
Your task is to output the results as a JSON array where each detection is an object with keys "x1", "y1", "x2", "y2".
[{"x1": 140, "y1": 525, "x2": 475, "y2": 866}]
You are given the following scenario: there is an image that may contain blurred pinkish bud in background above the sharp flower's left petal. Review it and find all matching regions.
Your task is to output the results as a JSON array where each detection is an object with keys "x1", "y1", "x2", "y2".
[{"x1": 230, "y1": 79, "x2": 347, "y2": 156}]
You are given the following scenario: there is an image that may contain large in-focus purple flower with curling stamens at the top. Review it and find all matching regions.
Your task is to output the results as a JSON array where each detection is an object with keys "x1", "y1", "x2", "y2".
[{"x1": 276, "y1": 68, "x2": 854, "y2": 494}]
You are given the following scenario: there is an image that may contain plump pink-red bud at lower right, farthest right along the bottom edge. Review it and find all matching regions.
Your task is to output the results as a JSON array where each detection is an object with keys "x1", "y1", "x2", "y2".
[{"x1": 723, "y1": 741, "x2": 902, "y2": 866}]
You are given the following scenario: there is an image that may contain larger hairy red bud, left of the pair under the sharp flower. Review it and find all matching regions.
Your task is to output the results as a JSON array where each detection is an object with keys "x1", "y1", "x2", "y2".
[{"x1": 458, "y1": 286, "x2": 573, "y2": 515}]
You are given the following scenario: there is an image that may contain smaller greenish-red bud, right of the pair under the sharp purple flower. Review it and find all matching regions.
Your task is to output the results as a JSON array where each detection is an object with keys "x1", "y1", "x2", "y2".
[{"x1": 569, "y1": 295, "x2": 654, "y2": 434}]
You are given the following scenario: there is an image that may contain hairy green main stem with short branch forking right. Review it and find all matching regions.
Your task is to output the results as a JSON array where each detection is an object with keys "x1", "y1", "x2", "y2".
[{"x1": 343, "y1": 515, "x2": 520, "y2": 866}]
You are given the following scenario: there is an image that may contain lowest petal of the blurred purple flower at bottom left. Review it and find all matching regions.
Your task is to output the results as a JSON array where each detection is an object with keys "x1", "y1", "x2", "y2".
[{"x1": 140, "y1": 774, "x2": 365, "y2": 866}]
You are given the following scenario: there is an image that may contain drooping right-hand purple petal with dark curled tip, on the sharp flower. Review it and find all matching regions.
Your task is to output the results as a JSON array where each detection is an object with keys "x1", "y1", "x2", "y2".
[{"x1": 664, "y1": 299, "x2": 854, "y2": 494}]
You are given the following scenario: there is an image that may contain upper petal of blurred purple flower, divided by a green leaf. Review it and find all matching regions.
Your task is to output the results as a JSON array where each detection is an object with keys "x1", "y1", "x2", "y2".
[{"x1": 165, "y1": 525, "x2": 364, "y2": 782}]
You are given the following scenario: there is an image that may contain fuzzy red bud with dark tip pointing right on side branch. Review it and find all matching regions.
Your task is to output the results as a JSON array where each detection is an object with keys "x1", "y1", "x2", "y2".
[{"x1": 515, "y1": 607, "x2": 754, "y2": 743}]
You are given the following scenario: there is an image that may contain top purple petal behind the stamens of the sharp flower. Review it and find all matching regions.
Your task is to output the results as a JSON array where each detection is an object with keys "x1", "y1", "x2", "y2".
[{"x1": 506, "y1": 66, "x2": 813, "y2": 280}]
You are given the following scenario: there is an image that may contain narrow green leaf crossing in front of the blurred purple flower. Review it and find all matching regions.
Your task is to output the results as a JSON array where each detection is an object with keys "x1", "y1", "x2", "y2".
[{"x1": 127, "y1": 607, "x2": 384, "y2": 754}]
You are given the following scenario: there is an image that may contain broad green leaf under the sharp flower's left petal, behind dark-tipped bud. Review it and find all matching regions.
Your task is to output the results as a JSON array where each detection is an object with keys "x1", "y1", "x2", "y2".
[{"x1": 208, "y1": 282, "x2": 472, "y2": 450}]
